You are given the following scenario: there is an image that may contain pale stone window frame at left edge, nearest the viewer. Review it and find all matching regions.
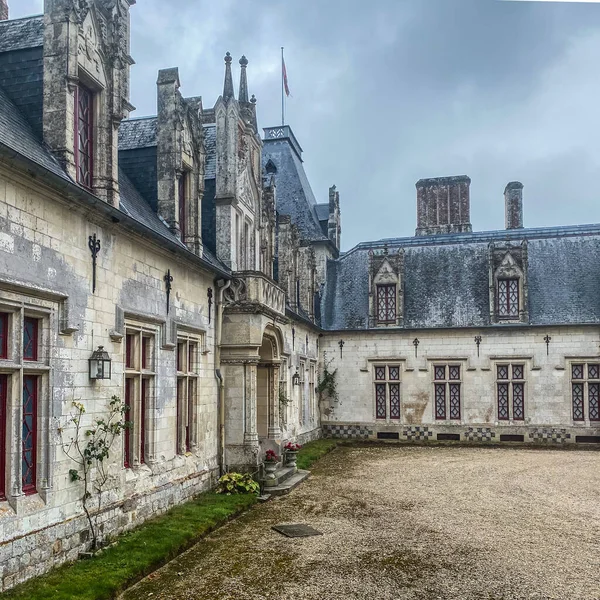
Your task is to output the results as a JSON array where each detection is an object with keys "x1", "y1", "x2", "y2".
[{"x1": 0, "y1": 291, "x2": 53, "y2": 513}]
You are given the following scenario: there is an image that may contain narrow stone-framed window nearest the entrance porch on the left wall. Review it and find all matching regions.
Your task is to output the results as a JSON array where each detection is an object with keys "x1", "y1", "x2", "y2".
[{"x1": 175, "y1": 328, "x2": 205, "y2": 455}]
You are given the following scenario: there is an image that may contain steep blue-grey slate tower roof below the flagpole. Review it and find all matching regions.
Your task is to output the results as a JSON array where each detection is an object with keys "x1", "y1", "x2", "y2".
[{"x1": 262, "y1": 127, "x2": 328, "y2": 241}]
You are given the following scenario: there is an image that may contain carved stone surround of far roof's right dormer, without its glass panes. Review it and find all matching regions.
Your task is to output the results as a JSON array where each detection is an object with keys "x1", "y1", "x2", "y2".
[{"x1": 489, "y1": 242, "x2": 529, "y2": 324}]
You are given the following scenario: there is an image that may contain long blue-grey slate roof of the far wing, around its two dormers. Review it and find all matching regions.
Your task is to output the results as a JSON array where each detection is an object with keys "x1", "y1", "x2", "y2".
[{"x1": 321, "y1": 225, "x2": 600, "y2": 329}]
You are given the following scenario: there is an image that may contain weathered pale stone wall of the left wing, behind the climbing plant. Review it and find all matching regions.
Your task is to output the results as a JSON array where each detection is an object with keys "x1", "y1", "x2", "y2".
[{"x1": 0, "y1": 165, "x2": 218, "y2": 588}]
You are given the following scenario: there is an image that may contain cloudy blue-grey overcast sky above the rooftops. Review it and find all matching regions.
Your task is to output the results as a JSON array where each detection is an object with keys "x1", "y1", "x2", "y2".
[{"x1": 9, "y1": 0, "x2": 600, "y2": 249}]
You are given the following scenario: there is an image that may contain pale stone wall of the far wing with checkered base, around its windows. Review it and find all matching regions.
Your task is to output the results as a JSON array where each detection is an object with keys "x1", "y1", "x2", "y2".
[{"x1": 322, "y1": 326, "x2": 600, "y2": 443}]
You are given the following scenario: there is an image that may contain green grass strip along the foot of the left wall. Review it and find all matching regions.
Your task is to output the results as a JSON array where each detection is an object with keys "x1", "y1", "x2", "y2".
[{"x1": 2, "y1": 492, "x2": 256, "y2": 600}]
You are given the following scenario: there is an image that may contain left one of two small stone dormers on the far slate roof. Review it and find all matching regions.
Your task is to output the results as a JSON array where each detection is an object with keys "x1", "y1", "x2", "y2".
[{"x1": 369, "y1": 247, "x2": 404, "y2": 327}]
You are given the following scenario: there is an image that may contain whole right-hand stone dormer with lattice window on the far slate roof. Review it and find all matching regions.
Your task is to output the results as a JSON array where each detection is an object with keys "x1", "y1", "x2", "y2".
[{"x1": 489, "y1": 240, "x2": 529, "y2": 323}]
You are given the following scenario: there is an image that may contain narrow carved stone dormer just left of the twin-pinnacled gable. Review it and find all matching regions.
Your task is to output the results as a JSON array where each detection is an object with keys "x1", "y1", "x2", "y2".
[{"x1": 157, "y1": 68, "x2": 206, "y2": 255}]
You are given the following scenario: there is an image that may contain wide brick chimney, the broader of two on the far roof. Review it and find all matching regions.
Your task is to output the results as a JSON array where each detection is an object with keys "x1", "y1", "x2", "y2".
[{"x1": 415, "y1": 175, "x2": 473, "y2": 235}]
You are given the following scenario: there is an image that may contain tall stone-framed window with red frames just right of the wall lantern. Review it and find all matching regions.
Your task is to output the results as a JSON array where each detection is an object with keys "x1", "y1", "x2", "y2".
[{"x1": 122, "y1": 319, "x2": 161, "y2": 470}]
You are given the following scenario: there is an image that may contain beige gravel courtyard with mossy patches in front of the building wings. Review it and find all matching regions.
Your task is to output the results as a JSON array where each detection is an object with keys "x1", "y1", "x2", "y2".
[{"x1": 123, "y1": 446, "x2": 600, "y2": 600}]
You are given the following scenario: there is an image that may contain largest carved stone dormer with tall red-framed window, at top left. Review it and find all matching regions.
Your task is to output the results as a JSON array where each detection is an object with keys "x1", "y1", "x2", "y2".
[{"x1": 43, "y1": 0, "x2": 135, "y2": 206}]
